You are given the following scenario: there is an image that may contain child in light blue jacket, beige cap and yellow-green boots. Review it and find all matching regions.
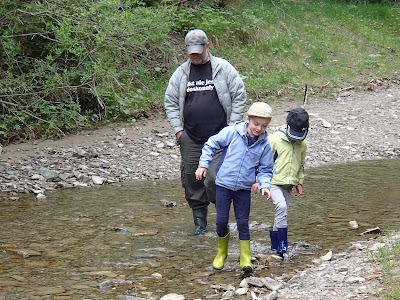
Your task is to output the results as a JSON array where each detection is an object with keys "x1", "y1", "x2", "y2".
[{"x1": 195, "y1": 102, "x2": 274, "y2": 271}]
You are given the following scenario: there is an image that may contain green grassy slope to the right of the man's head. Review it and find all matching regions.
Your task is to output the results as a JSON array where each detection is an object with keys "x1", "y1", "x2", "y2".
[{"x1": 205, "y1": 1, "x2": 400, "y2": 101}]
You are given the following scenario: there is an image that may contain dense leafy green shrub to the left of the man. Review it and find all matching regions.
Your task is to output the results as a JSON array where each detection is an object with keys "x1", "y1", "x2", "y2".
[{"x1": 0, "y1": 0, "x2": 171, "y2": 143}]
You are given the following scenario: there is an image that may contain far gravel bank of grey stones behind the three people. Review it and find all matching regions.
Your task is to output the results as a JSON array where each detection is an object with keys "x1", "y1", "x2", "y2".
[{"x1": 0, "y1": 86, "x2": 400, "y2": 198}]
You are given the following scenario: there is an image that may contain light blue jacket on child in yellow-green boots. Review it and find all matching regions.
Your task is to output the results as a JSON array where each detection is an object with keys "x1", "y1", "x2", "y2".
[{"x1": 199, "y1": 121, "x2": 274, "y2": 191}]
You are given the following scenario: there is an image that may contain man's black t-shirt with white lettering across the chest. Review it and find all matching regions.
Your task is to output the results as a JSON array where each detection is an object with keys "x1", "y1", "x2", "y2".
[{"x1": 183, "y1": 61, "x2": 227, "y2": 143}]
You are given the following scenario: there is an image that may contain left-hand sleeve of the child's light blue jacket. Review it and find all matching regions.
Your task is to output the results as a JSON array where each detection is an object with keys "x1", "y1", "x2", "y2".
[{"x1": 199, "y1": 126, "x2": 233, "y2": 169}]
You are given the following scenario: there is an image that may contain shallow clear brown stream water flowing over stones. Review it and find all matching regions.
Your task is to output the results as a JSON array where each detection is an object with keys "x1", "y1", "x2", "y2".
[{"x1": 0, "y1": 159, "x2": 400, "y2": 300}]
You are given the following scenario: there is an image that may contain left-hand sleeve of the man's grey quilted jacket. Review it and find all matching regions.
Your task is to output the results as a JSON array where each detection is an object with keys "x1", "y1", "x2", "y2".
[{"x1": 164, "y1": 68, "x2": 183, "y2": 134}]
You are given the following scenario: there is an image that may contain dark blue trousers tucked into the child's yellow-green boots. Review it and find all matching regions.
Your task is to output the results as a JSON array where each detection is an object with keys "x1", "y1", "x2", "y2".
[{"x1": 215, "y1": 185, "x2": 251, "y2": 241}]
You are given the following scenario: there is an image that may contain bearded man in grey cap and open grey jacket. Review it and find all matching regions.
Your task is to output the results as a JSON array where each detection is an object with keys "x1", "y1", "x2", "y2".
[{"x1": 164, "y1": 29, "x2": 247, "y2": 235}]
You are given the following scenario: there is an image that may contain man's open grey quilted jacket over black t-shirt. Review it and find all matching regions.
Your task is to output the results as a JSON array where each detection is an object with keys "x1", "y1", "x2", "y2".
[{"x1": 164, "y1": 53, "x2": 247, "y2": 134}]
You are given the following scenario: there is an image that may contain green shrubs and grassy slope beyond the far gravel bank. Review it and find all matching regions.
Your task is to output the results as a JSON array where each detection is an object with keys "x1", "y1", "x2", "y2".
[{"x1": 0, "y1": 0, "x2": 400, "y2": 144}]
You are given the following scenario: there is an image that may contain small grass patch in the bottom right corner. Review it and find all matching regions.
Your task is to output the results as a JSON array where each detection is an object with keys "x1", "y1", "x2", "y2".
[{"x1": 373, "y1": 234, "x2": 400, "y2": 299}]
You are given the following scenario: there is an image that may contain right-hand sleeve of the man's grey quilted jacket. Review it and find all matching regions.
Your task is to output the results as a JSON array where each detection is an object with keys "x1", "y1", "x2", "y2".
[{"x1": 227, "y1": 64, "x2": 247, "y2": 125}]
